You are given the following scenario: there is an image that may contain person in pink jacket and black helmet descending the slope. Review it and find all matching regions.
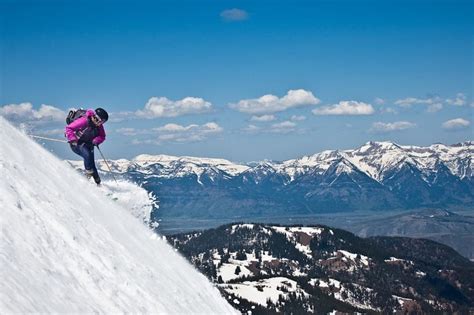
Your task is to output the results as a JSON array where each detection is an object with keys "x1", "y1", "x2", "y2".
[{"x1": 65, "y1": 108, "x2": 109, "y2": 185}]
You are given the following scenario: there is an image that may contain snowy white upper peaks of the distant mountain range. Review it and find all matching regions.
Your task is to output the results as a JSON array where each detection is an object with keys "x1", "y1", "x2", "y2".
[{"x1": 83, "y1": 141, "x2": 474, "y2": 182}]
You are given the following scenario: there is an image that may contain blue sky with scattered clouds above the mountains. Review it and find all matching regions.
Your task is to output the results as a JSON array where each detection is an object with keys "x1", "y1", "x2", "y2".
[{"x1": 0, "y1": 0, "x2": 474, "y2": 161}]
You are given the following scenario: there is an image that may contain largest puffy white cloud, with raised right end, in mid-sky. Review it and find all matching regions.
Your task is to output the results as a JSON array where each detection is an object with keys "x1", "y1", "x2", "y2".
[{"x1": 230, "y1": 89, "x2": 320, "y2": 114}]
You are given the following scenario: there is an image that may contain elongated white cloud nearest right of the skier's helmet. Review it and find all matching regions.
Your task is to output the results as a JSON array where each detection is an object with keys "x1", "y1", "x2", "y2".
[{"x1": 135, "y1": 97, "x2": 212, "y2": 119}]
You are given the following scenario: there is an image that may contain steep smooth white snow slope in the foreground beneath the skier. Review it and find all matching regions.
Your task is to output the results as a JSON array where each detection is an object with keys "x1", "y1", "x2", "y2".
[{"x1": 0, "y1": 117, "x2": 235, "y2": 314}]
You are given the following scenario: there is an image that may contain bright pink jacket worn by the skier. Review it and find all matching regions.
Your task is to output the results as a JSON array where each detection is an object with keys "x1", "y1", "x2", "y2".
[{"x1": 65, "y1": 109, "x2": 105, "y2": 145}]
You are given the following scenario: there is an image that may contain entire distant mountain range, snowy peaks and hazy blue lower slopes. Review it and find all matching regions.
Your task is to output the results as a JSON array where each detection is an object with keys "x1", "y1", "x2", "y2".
[{"x1": 71, "y1": 141, "x2": 474, "y2": 222}]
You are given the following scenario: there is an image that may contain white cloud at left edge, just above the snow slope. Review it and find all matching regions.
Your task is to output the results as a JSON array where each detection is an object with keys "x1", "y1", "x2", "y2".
[{"x1": 0, "y1": 102, "x2": 66, "y2": 122}]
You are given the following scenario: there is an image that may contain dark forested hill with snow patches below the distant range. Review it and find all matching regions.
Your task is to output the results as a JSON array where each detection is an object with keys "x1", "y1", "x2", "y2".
[{"x1": 168, "y1": 223, "x2": 474, "y2": 314}]
